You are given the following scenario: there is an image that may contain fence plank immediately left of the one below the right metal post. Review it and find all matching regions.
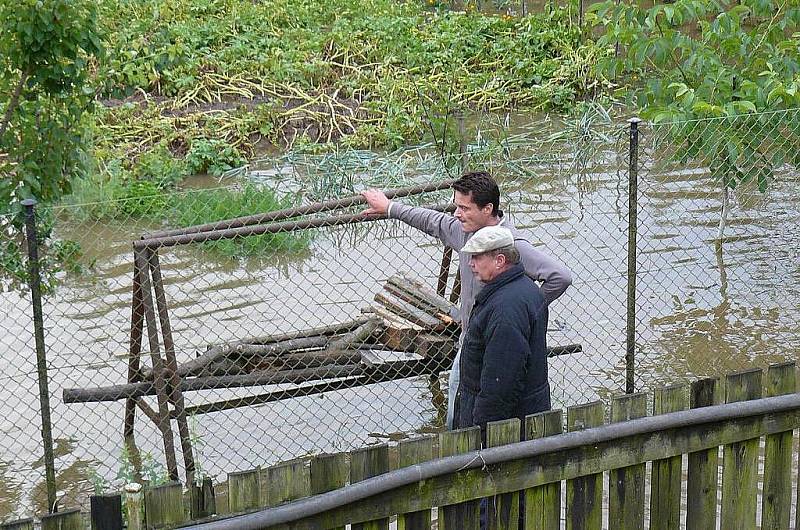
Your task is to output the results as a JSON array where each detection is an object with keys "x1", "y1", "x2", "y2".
[{"x1": 567, "y1": 401, "x2": 605, "y2": 530}]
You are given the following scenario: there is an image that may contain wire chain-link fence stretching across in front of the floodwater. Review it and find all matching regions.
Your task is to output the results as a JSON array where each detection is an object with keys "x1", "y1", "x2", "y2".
[{"x1": 0, "y1": 112, "x2": 800, "y2": 514}]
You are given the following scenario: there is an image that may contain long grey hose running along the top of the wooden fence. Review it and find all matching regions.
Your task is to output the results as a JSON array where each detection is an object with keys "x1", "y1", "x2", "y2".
[{"x1": 182, "y1": 394, "x2": 800, "y2": 530}]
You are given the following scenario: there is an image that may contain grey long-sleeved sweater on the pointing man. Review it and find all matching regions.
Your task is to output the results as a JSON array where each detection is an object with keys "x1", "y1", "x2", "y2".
[{"x1": 387, "y1": 202, "x2": 572, "y2": 337}]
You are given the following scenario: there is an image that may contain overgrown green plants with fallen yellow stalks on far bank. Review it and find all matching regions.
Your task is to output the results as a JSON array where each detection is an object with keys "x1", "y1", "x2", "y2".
[{"x1": 89, "y1": 0, "x2": 598, "y2": 162}]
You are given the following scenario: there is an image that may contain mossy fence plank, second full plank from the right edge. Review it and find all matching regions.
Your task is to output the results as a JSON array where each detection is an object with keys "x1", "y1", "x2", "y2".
[{"x1": 720, "y1": 369, "x2": 761, "y2": 530}]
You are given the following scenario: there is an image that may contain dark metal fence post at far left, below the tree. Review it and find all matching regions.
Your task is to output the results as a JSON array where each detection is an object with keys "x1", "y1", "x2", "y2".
[{"x1": 21, "y1": 199, "x2": 56, "y2": 513}]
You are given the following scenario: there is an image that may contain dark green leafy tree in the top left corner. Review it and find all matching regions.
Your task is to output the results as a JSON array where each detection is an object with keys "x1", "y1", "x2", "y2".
[{"x1": 0, "y1": 0, "x2": 102, "y2": 292}]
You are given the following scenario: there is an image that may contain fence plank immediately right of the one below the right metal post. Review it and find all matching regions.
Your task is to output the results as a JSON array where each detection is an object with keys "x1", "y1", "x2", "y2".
[{"x1": 650, "y1": 385, "x2": 687, "y2": 530}]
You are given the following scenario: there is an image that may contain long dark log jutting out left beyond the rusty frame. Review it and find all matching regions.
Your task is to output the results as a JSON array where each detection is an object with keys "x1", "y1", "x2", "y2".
[{"x1": 63, "y1": 364, "x2": 364, "y2": 403}]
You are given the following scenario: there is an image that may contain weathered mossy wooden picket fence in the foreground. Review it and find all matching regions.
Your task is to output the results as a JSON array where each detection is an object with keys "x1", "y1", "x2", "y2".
[{"x1": 2, "y1": 362, "x2": 800, "y2": 530}]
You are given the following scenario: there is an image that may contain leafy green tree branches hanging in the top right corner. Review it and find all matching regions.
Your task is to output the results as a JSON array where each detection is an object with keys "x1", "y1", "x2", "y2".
[{"x1": 592, "y1": 0, "x2": 800, "y2": 190}]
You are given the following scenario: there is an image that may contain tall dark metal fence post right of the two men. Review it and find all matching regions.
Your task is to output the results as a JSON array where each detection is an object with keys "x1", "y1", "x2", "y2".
[{"x1": 625, "y1": 118, "x2": 642, "y2": 394}]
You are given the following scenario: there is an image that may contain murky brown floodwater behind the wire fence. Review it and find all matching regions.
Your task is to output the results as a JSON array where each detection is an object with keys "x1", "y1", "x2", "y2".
[{"x1": 0, "y1": 144, "x2": 800, "y2": 517}]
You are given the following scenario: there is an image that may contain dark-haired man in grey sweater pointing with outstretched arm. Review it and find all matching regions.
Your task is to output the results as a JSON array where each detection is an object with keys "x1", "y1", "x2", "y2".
[{"x1": 362, "y1": 171, "x2": 572, "y2": 428}]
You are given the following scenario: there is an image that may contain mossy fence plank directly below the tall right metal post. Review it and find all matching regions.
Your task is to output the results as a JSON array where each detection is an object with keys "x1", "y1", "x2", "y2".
[{"x1": 608, "y1": 392, "x2": 647, "y2": 530}]
